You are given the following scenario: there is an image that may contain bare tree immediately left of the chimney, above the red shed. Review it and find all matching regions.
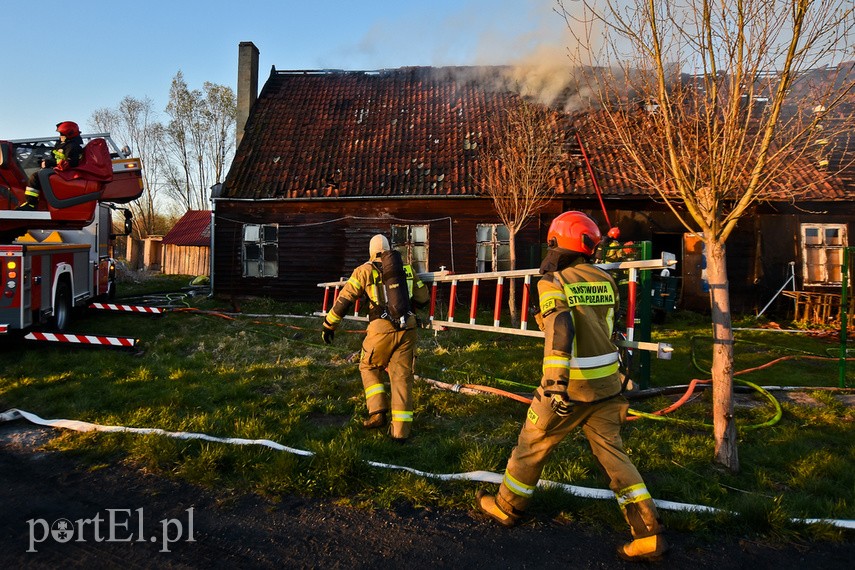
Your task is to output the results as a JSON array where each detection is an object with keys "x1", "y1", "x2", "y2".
[{"x1": 166, "y1": 71, "x2": 237, "y2": 210}]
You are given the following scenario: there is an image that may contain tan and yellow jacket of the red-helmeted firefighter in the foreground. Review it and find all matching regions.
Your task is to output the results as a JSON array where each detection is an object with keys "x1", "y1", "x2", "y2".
[{"x1": 537, "y1": 258, "x2": 621, "y2": 402}]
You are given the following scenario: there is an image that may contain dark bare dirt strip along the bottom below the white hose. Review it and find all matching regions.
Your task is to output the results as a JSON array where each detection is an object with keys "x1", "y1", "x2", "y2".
[{"x1": 0, "y1": 421, "x2": 855, "y2": 570}]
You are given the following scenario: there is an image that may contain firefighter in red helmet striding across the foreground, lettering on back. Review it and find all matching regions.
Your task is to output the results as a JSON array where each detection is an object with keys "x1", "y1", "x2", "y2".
[{"x1": 477, "y1": 211, "x2": 668, "y2": 560}]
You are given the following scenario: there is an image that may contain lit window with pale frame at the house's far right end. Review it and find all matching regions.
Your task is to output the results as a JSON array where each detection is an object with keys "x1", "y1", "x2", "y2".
[{"x1": 802, "y1": 224, "x2": 848, "y2": 285}]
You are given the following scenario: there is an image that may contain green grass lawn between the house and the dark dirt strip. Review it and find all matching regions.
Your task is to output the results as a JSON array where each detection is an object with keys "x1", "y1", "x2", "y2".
[{"x1": 0, "y1": 277, "x2": 855, "y2": 541}]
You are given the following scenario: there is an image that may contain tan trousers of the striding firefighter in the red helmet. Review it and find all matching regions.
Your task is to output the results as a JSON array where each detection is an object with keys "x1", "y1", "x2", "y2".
[{"x1": 496, "y1": 387, "x2": 661, "y2": 538}]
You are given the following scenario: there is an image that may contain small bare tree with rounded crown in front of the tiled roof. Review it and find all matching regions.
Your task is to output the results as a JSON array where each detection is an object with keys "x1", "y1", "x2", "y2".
[{"x1": 482, "y1": 98, "x2": 565, "y2": 325}]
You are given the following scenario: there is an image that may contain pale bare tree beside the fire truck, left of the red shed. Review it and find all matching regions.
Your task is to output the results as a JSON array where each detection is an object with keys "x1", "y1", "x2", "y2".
[{"x1": 89, "y1": 96, "x2": 171, "y2": 237}]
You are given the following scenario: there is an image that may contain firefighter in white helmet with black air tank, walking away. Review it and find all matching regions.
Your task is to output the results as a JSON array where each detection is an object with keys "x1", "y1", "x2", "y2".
[{"x1": 322, "y1": 234, "x2": 429, "y2": 442}]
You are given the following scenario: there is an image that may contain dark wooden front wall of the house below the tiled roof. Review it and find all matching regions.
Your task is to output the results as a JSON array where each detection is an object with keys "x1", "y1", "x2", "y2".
[{"x1": 214, "y1": 198, "x2": 855, "y2": 313}]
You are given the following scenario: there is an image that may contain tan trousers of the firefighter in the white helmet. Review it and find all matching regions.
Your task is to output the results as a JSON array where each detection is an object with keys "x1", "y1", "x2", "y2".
[{"x1": 359, "y1": 318, "x2": 418, "y2": 439}]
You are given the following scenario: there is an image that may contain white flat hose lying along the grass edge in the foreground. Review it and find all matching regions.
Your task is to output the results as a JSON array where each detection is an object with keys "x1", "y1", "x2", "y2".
[{"x1": 0, "y1": 408, "x2": 855, "y2": 529}]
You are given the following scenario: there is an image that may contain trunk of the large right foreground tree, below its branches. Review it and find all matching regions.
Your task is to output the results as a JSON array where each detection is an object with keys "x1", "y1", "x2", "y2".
[{"x1": 706, "y1": 239, "x2": 739, "y2": 473}]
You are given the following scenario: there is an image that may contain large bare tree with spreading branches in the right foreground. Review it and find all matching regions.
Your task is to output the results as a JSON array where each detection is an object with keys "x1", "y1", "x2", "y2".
[{"x1": 558, "y1": 0, "x2": 855, "y2": 472}]
